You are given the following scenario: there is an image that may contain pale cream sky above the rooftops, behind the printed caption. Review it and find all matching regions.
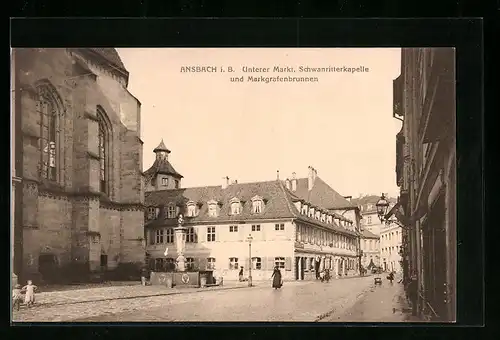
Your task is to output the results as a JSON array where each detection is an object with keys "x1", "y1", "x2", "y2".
[{"x1": 118, "y1": 48, "x2": 401, "y2": 197}]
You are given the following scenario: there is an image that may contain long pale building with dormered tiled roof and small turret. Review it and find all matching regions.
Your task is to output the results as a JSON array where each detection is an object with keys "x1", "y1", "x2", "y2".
[{"x1": 145, "y1": 146, "x2": 358, "y2": 280}]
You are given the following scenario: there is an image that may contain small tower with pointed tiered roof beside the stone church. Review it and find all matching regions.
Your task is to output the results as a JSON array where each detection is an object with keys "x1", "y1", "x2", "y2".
[{"x1": 144, "y1": 139, "x2": 183, "y2": 191}]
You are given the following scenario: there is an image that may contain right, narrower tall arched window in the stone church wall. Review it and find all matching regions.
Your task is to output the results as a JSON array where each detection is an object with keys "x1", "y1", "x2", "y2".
[{"x1": 97, "y1": 106, "x2": 111, "y2": 194}]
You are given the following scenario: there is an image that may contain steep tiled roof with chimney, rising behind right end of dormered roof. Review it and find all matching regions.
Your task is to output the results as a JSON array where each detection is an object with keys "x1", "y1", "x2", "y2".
[{"x1": 294, "y1": 177, "x2": 356, "y2": 209}]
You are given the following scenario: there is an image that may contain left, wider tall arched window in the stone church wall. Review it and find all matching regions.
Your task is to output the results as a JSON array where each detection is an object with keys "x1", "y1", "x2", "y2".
[{"x1": 36, "y1": 82, "x2": 63, "y2": 181}]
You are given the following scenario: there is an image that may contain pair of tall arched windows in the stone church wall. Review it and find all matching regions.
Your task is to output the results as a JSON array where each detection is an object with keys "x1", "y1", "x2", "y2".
[{"x1": 36, "y1": 82, "x2": 112, "y2": 194}]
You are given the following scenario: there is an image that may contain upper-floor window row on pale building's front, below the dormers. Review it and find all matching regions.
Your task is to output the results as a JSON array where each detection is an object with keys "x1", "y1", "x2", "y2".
[{"x1": 150, "y1": 223, "x2": 285, "y2": 244}]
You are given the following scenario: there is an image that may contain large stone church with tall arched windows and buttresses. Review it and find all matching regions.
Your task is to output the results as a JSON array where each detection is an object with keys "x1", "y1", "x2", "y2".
[{"x1": 13, "y1": 48, "x2": 144, "y2": 282}]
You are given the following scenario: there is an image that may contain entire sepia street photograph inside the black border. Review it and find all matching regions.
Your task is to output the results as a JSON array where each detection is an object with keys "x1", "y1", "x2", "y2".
[{"x1": 10, "y1": 47, "x2": 457, "y2": 323}]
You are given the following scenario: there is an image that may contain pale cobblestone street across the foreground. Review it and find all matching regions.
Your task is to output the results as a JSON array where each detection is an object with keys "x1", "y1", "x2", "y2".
[{"x1": 14, "y1": 276, "x2": 413, "y2": 322}]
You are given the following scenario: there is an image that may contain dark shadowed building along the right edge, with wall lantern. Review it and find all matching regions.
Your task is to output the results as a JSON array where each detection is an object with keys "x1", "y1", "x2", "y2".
[{"x1": 389, "y1": 48, "x2": 456, "y2": 321}]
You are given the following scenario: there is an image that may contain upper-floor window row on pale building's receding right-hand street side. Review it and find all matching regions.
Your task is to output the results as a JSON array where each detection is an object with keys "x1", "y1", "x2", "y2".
[{"x1": 296, "y1": 225, "x2": 357, "y2": 250}]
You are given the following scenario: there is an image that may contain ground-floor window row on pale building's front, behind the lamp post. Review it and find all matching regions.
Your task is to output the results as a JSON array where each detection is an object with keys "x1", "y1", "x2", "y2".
[{"x1": 152, "y1": 256, "x2": 286, "y2": 270}]
